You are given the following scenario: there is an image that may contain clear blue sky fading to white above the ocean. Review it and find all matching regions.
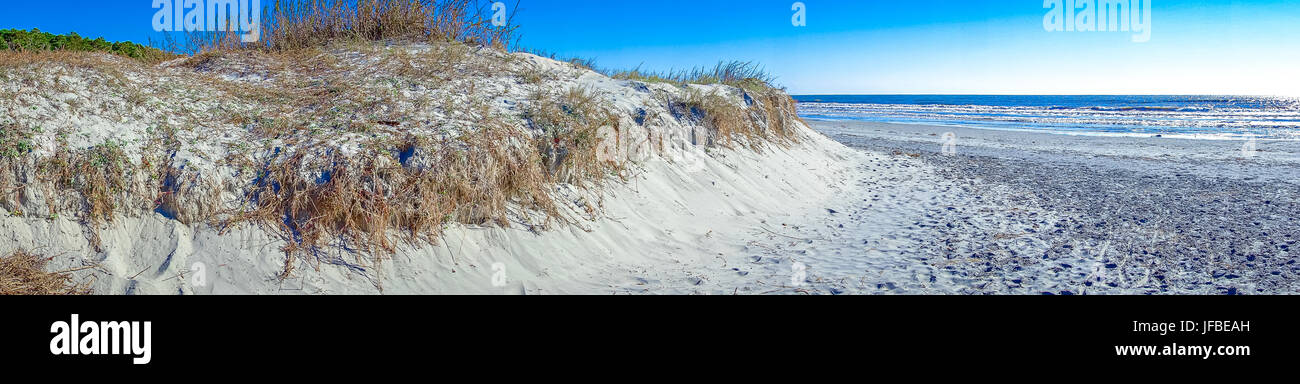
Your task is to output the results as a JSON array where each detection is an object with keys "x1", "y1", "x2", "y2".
[{"x1": 0, "y1": 0, "x2": 1300, "y2": 96}]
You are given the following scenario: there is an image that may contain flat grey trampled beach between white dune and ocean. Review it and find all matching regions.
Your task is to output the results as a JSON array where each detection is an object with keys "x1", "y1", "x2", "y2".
[{"x1": 764, "y1": 121, "x2": 1300, "y2": 294}]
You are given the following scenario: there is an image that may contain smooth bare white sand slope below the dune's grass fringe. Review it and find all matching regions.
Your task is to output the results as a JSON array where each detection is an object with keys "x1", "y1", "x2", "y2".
[{"x1": 0, "y1": 131, "x2": 873, "y2": 294}]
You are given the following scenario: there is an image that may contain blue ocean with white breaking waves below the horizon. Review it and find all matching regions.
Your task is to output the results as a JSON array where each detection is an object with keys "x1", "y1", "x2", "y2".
[{"x1": 794, "y1": 95, "x2": 1300, "y2": 139}]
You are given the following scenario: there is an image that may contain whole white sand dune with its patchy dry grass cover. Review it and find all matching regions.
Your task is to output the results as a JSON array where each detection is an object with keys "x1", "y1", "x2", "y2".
[{"x1": 0, "y1": 43, "x2": 862, "y2": 294}]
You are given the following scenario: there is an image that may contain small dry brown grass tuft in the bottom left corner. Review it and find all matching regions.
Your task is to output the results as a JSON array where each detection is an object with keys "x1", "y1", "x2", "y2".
[{"x1": 0, "y1": 250, "x2": 91, "y2": 295}]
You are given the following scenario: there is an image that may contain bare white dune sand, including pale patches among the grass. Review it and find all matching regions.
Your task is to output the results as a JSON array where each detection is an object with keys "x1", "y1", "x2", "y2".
[{"x1": 0, "y1": 44, "x2": 883, "y2": 294}]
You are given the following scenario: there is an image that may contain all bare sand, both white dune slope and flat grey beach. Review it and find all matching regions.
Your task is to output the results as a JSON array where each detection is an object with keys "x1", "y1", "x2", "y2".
[{"x1": 0, "y1": 46, "x2": 1300, "y2": 294}]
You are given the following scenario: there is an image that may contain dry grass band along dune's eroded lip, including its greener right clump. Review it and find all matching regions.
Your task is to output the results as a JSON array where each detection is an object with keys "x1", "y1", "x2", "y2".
[{"x1": 220, "y1": 82, "x2": 620, "y2": 277}]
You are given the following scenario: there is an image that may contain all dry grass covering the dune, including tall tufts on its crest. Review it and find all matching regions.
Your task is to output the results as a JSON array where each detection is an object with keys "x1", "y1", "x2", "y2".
[{"x1": 0, "y1": 0, "x2": 798, "y2": 290}]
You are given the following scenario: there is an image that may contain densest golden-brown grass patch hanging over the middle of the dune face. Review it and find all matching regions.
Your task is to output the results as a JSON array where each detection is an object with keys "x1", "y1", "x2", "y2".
[{"x1": 224, "y1": 121, "x2": 556, "y2": 277}]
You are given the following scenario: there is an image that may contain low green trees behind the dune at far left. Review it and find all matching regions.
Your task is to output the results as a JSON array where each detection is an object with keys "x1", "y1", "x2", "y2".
[{"x1": 0, "y1": 29, "x2": 168, "y2": 60}]
